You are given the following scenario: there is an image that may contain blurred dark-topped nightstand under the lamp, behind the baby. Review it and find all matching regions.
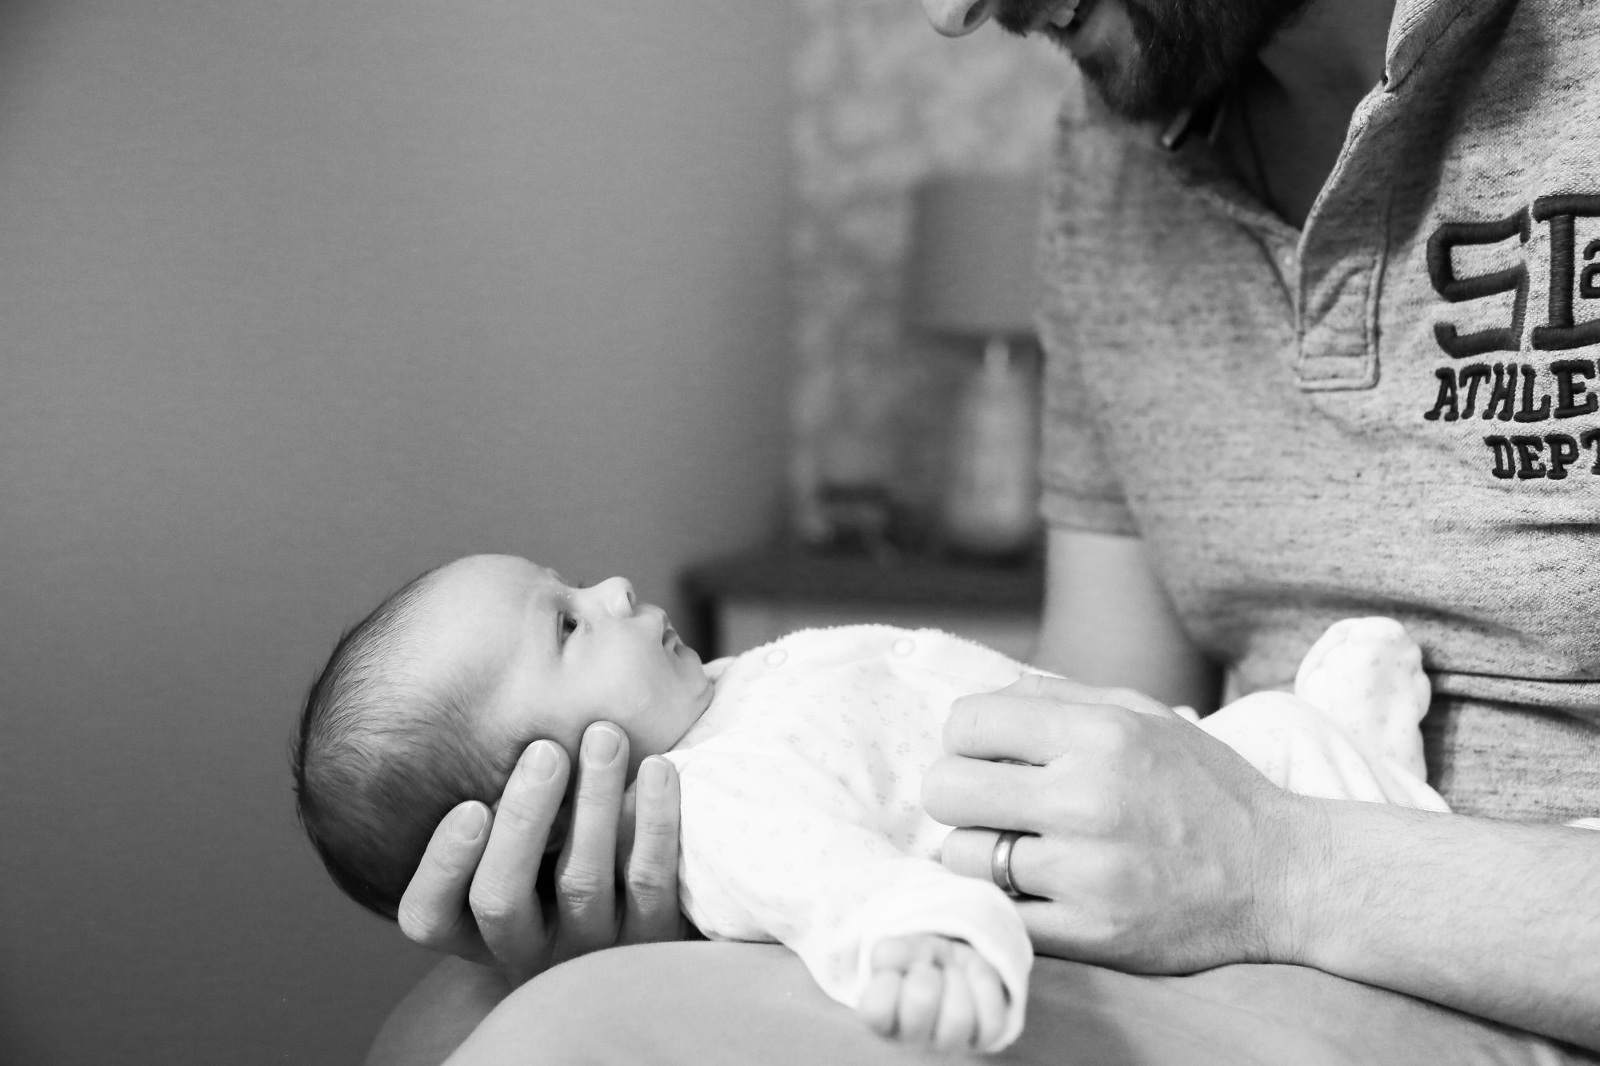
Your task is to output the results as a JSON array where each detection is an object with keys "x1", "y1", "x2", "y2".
[{"x1": 680, "y1": 547, "x2": 1045, "y2": 661}]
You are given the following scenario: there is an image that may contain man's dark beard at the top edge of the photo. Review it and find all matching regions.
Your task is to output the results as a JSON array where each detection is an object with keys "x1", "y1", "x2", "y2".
[{"x1": 995, "y1": 0, "x2": 1309, "y2": 118}]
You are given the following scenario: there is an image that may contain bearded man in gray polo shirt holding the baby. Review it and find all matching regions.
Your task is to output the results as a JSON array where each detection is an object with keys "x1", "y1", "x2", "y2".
[{"x1": 373, "y1": 0, "x2": 1600, "y2": 1063}]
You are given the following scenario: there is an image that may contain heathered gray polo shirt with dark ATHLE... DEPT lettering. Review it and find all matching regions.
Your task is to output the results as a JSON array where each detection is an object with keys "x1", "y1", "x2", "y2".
[{"x1": 1042, "y1": 0, "x2": 1600, "y2": 818}]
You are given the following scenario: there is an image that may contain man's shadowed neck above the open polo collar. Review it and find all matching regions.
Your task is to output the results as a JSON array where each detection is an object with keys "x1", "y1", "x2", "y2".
[{"x1": 1235, "y1": 0, "x2": 1395, "y2": 226}]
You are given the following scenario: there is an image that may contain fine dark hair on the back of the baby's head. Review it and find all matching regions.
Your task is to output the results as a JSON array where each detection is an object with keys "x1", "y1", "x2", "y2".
[{"x1": 291, "y1": 568, "x2": 515, "y2": 920}]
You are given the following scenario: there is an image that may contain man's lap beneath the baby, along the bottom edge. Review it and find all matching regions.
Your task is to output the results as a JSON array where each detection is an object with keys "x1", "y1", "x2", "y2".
[{"x1": 450, "y1": 943, "x2": 1597, "y2": 1066}]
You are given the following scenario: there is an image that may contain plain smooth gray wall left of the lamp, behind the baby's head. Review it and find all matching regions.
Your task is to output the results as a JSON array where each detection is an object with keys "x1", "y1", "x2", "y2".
[{"x1": 0, "y1": 0, "x2": 794, "y2": 1066}]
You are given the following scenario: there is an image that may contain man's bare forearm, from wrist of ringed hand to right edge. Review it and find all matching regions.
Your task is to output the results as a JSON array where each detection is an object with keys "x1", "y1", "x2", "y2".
[{"x1": 1285, "y1": 800, "x2": 1600, "y2": 1050}]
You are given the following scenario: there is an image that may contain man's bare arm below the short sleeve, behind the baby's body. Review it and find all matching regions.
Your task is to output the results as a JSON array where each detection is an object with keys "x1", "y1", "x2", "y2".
[{"x1": 1034, "y1": 530, "x2": 1219, "y2": 714}]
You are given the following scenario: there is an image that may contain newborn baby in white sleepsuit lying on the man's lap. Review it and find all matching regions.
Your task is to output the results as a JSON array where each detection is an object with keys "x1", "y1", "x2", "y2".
[{"x1": 294, "y1": 555, "x2": 1445, "y2": 1050}]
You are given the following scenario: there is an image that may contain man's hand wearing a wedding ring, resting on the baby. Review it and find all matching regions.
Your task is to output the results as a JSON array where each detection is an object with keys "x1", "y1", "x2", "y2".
[{"x1": 923, "y1": 675, "x2": 1315, "y2": 973}]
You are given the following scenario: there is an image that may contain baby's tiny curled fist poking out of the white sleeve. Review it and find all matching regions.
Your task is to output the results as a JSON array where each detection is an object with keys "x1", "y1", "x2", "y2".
[{"x1": 856, "y1": 933, "x2": 1006, "y2": 1052}]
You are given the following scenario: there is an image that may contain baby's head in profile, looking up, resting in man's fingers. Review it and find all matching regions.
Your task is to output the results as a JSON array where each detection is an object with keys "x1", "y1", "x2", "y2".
[{"x1": 294, "y1": 555, "x2": 712, "y2": 919}]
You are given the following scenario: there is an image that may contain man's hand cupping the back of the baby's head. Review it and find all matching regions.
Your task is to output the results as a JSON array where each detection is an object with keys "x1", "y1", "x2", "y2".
[{"x1": 398, "y1": 722, "x2": 685, "y2": 988}]
